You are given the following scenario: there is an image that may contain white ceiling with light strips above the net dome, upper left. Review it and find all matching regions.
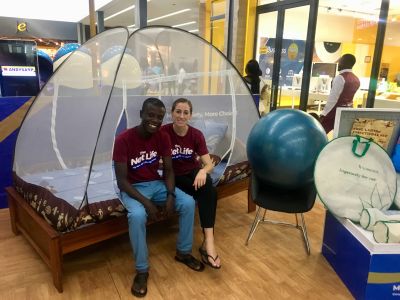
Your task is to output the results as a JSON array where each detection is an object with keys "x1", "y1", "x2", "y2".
[{"x1": 0, "y1": 0, "x2": 200, "y2": 31}]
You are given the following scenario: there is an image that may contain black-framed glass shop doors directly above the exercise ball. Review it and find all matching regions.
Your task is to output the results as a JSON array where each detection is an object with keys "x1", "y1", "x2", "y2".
[{"x1": 255, "y1": 0, "x2": 315, "y2": 113}]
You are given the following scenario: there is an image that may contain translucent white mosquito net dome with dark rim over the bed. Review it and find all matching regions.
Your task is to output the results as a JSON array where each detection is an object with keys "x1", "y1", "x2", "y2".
[{"x1": 14, "y1": 26, "x2": 259, "y2": 227}]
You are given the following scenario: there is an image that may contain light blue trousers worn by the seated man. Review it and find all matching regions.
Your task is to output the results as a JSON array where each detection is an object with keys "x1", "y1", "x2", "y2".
[{"x1": 121, "y1": 180, "x2": 195, "y2": 272}]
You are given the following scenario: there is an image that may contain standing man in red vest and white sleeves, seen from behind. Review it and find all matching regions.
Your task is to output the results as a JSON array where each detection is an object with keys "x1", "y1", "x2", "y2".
[{"x1": 320, "y1": 54, "x2": 360, "y2": 133}]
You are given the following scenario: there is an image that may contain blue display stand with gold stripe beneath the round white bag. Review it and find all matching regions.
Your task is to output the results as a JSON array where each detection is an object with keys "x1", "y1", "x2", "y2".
[{"x1": 322, "y1": 211, "x2": 400, "y2": 300}]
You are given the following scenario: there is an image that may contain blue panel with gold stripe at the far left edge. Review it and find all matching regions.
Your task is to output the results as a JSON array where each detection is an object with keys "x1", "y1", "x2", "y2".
[{"x1": 0, "y1": 97, "x2": 31, "y2": 209}]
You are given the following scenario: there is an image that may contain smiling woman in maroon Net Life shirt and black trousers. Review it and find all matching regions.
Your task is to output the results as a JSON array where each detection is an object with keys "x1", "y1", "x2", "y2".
[{"x1": 162, "y1": 98, "x2": 221, "y2": 269}]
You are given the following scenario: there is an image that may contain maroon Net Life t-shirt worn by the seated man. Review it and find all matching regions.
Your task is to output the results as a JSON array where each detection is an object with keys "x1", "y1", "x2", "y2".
[{"x1": 113, "y1": 127, "x2": 171, "y2": 183}]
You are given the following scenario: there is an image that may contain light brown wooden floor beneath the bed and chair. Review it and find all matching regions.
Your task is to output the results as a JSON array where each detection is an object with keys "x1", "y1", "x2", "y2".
[{"x1": 0, "y1": 192, "x2": 352, "y2": 300}]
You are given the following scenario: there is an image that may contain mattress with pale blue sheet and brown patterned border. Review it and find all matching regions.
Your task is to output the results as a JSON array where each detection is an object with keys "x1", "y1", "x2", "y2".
[{"x1": 13, "y1": 161, "x2": 250, "y2": 232}]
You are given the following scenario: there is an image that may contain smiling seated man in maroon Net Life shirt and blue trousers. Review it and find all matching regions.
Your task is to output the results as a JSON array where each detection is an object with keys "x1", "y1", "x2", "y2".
[{"x1": 113, "y1": 98, "x2": 204, "y2": 297}]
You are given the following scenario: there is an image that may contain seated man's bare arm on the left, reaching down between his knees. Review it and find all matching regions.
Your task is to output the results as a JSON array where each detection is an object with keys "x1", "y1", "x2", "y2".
[{"x1": 114, "y1": 161, "x2": 158, "y2": 220}]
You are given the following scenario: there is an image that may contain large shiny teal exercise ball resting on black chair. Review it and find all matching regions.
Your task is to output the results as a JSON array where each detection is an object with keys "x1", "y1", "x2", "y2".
[{"x1": 247, "y1": 109, "x2": 328, "y2": 189}]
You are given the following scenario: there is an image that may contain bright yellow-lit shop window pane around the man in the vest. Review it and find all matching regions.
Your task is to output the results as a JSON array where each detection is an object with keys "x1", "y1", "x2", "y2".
[{"x1": 314, "y1": 0, "x2": 381, "y2": 114}]
